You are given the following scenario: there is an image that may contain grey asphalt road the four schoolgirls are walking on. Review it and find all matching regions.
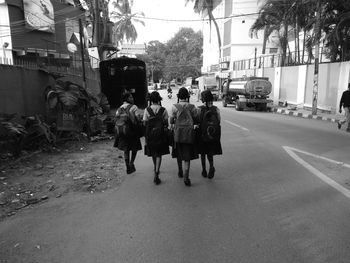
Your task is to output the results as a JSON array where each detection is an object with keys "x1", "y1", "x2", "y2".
[{"x1": 0, "y1": 90, "x2": 350, "y2": 263}]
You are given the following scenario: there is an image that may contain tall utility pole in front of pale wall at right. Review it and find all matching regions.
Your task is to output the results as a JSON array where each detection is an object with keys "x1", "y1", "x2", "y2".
[{"x1": 312, "y1": 0, "x2": 321, "y2": 115}]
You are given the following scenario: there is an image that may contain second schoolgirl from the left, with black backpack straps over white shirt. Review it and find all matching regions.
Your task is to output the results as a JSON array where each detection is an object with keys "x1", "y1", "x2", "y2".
[{"x1": 143, "y1": 91, "x2": 170, "y2": 185}]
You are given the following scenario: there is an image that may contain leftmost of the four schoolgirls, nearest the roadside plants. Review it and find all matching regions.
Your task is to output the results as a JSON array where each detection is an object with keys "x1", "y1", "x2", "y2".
[{"x1": 114, "y1": 92, "x2": 142, "y2": 174}]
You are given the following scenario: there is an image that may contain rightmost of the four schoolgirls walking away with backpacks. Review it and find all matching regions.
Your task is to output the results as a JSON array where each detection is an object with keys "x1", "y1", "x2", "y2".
[{"x1": 197, "y1": 90, "x2": 222, "y2": 179}]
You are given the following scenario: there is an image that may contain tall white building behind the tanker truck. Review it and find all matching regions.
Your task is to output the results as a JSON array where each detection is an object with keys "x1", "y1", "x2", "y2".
[{"x1": 202, "y1": 0, "x2": 277, "y2": 78}]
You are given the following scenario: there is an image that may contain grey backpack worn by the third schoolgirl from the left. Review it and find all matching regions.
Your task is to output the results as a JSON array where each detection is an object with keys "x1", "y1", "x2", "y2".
[{"x1": 174, "y1": 104, "x2": 194, "y2": 144}]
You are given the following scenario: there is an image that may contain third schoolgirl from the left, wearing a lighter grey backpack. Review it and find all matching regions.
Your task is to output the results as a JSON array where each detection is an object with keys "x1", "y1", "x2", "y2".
[{"x1": 170, "y1": 87, "x2": 198, "y2": 186}]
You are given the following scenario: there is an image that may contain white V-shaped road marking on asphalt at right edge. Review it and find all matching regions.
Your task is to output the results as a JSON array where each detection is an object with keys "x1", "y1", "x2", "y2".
[{"x1": 283, "y1": 146, "x2": 350, "y2": 198}]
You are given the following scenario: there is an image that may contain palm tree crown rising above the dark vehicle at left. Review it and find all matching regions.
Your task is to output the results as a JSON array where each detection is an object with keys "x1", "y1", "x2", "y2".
[{"x1": 111, "y1": 0, "x2": 145, "y2": 43}]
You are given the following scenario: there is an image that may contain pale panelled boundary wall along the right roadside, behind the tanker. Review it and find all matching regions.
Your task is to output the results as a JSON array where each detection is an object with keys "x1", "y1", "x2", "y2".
[{"x1": 231, "y1": 61, "x2": 350, "y2": 113}]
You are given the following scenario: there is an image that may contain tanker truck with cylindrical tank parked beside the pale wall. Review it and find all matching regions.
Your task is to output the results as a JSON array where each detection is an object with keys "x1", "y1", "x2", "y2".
[{"x1": 222, "y1": 77, "x2": 272, "y2": 111}]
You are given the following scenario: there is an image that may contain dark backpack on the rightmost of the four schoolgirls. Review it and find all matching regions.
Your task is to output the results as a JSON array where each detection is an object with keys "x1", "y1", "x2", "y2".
[{"x1": 200, "y1": 106, "x2": 221, "y2": 142}]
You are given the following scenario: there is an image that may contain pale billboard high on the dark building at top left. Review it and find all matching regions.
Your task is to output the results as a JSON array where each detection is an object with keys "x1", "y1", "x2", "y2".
[{"x1": 23, "y1": 0, "x2": 55, "y2": 33}]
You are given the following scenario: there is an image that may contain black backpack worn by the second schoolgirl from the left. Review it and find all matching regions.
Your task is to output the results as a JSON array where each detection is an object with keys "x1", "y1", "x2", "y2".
[{"x1": 145, "y1": 107, "x2": 166, "y2": 147}]
